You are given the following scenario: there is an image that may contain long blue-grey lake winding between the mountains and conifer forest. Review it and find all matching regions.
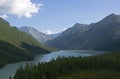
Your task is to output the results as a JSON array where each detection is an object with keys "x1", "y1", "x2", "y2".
[{"x1": 0, "y1": 50, "x2": 106, "y2": 79}]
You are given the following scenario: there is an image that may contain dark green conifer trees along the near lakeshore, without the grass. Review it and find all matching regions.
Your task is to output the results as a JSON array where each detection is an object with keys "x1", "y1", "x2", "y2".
[{"x1": 10, "y1": 53, "x2": 120, "y2": 79}]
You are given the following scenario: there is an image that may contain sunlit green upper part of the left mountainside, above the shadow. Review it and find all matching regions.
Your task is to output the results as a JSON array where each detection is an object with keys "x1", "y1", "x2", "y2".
[{"x1": 0, "y1": 18, "x2": 55, "y2": 52}]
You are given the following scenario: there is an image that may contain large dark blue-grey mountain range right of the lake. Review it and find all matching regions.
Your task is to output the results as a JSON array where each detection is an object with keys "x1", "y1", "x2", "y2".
[{"x1": 46, "y1": 14, "x2": 120, "y2": 50}]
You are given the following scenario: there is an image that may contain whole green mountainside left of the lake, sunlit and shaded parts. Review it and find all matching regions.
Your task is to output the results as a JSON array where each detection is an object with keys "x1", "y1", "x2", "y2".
[{"x1": 0, "y1": 18, "x2": 54, "y2": 67}]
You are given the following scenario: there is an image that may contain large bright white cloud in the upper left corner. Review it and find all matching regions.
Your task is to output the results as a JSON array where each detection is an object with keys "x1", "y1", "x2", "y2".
[{"x1": 0, "y1": 0, "x2": 42, "y2": 18}]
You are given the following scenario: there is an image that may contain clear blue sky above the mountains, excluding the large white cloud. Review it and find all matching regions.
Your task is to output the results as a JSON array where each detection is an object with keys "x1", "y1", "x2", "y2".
[{"x1": 1, "y1": 0, "x2": 120, "y2": 33}]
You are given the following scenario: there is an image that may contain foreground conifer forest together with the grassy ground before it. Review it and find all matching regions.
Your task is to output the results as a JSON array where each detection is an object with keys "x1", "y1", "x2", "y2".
[{"x1": 10, "y1": 52, "x2": 120, "y2": 79}]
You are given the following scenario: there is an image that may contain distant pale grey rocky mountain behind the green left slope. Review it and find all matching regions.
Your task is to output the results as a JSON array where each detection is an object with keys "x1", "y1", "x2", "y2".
[{"x1": 19, "y1": 26, "x2": 52, "y2": 44}]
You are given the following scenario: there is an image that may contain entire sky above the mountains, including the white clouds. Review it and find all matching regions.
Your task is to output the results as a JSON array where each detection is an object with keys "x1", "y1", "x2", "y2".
[{"x1": 0, "y1": 0, "x2": 120, "y2": 34}]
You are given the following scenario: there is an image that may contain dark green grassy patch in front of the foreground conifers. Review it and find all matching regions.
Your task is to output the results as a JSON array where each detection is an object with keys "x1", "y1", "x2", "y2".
[{"x1": 57, "y1": 70, "x2": 120, "y2": 79}]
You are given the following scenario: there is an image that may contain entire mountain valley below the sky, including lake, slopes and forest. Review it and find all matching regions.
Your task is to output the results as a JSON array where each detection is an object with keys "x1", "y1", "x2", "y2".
[{"x1": 0, "y1": 14, "x2": 120, "y2": 79}]
